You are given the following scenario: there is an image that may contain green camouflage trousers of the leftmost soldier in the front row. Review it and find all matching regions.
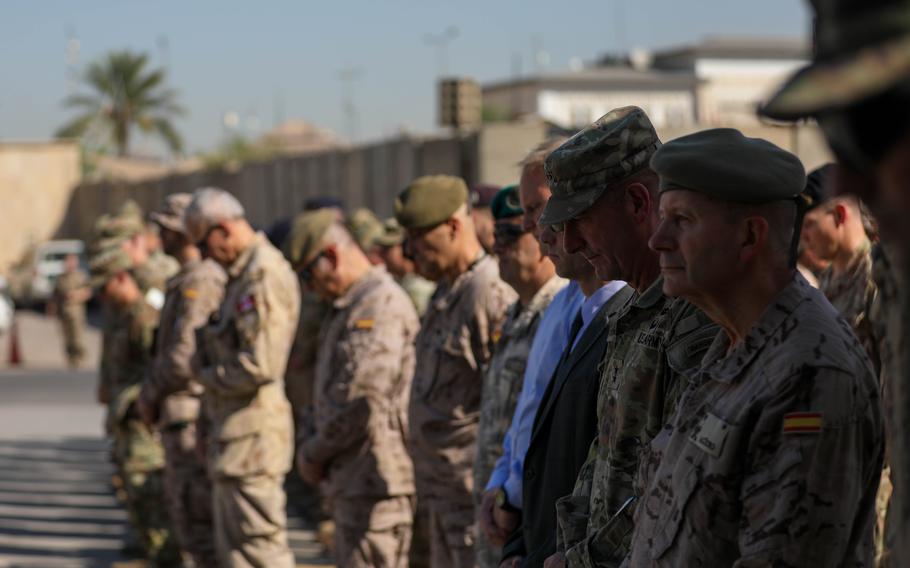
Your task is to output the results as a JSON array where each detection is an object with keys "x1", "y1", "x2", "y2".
[{"x1": 114, "y1": 418, "x2": 181, "y2": 567}]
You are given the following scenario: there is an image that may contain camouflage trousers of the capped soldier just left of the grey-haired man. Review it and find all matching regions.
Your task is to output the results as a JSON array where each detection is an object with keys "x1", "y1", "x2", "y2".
[{"x1": 161, "y1": 422, "x2": 216, "y2": 568}]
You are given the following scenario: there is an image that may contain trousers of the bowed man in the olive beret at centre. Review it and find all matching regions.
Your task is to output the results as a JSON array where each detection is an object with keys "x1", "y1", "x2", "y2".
[{"x1": 426, "y1": 497, "x2": 477, "y2": 568}]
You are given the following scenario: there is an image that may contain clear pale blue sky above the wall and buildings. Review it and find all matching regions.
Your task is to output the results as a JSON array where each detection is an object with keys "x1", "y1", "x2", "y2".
[{"x1": 0, "y1": 0, "x2": 809, "y2": 155}]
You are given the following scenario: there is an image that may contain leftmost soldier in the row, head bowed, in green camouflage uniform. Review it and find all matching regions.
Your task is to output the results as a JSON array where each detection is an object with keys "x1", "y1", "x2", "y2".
[{"x1": 91, "y1": 246, "x2": 180, "y2": 566}]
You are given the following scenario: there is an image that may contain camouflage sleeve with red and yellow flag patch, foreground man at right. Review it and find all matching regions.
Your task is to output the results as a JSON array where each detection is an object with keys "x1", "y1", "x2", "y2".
[{"x1": 734, "y1": 367, "x2": 883, "y2": 566}]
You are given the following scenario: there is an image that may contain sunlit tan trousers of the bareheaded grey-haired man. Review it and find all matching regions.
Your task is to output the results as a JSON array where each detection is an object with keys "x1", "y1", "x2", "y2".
[{"x1": 213, "y1": 475, "x2": 294, "y2": 568}]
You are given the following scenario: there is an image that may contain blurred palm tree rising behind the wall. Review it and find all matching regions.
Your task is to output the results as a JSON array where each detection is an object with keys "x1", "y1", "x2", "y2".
[{"x1": 57, "y1": 51, "x2": 183, "y2": 156}]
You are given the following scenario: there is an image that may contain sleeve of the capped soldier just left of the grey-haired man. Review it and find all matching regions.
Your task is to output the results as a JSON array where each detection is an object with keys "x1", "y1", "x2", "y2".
[{"x1": 143, "y1": 275, "x2": 224, "y2": 403}]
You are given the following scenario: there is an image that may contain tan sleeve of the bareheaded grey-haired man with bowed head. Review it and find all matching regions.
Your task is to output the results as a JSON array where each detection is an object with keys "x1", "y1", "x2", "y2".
[{"x1": 199, "y1": 278, "x2": 282, "y2": 397}]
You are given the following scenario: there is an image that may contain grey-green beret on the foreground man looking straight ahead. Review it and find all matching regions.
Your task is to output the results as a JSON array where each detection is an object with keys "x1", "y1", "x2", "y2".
[{"x1": 651, "y1": 128, "x2": 806, "y2": 203}]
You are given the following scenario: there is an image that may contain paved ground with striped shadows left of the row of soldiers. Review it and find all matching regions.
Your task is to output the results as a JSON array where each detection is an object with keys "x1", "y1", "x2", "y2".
[{"x1": 0, "y1": 314, "x2": 328, "y2": 568}]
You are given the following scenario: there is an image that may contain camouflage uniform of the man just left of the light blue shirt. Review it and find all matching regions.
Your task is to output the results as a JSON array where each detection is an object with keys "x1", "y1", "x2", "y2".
[{"x1": 474, "y1": 276, "x2": 567, "y2": 568}]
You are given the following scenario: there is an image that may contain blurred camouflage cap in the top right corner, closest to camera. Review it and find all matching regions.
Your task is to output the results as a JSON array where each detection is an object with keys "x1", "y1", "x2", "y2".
[{"x1": 759, "y1": 0, "x2": 910, "y2": 120}]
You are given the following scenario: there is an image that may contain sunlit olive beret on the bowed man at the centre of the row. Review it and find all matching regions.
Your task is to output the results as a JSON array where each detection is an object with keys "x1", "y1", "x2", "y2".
[{"x1": 395, "y1": 175, "x2": 468, "y2": 229}]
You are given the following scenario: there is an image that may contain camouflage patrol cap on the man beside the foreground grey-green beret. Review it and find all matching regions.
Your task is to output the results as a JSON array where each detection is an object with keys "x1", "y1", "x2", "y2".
[{"x1": 539, "y1": 106, "x2": 660, "y2": 225}]
